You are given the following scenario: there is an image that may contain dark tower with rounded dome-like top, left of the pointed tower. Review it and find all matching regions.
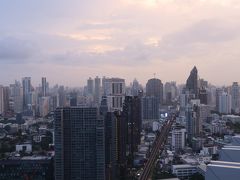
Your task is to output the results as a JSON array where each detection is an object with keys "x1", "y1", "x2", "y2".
[{"x1": 146, "y1": 78, "x2": 163, "y2": 104}]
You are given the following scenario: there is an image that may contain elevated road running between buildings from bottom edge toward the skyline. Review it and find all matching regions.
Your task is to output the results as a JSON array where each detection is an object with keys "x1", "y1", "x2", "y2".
[{"x1": 139, "y1": 115, "x2": 175, "y2": 180}]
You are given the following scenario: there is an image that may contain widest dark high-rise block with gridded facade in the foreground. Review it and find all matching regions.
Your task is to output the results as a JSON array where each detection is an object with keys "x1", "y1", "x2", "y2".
[{"x1": 55, "y1": 107, "x2": 105, "y2": 180}]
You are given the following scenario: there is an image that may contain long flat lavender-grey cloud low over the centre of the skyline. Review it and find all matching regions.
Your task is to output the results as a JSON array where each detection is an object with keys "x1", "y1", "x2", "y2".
[{"x1": 53, "y1": 42, "x2": 150, "y2": 67}]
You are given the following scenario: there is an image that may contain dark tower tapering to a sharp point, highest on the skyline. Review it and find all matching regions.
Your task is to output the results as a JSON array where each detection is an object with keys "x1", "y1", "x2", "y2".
[{"x1": 186, "y1": 66, "x2": 199, "y2": 98}]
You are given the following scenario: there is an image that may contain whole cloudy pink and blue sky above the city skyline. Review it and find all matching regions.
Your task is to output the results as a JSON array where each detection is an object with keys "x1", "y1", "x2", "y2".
[{"x1": 0, "y1": 0, "x2": 240, "y2": 86}]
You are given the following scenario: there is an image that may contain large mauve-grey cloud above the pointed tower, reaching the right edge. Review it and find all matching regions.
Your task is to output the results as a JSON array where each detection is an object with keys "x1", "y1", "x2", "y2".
[{"x1": 156, "y1": 19, "x2": 240, "y2": 60}]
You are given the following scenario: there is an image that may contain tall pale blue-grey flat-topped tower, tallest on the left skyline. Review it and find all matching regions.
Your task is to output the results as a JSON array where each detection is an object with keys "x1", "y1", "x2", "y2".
[{"x1": 22, "y1": 77, "x2": 32, "y2": 109}]
